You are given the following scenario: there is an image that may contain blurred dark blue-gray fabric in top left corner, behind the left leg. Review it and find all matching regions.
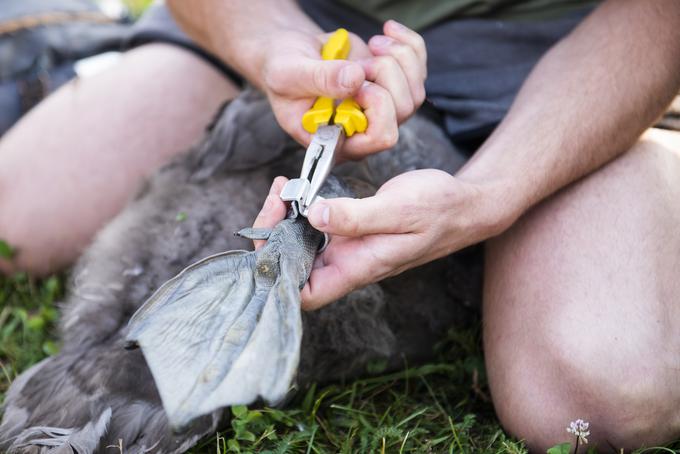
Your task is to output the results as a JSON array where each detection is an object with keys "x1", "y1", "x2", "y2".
[{"x1": 0, "y1": 0, "x2": 129, "y2": 137}]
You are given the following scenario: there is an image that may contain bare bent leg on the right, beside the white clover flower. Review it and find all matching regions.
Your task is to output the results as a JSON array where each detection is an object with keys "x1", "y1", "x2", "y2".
[{"x1": 484, "y1": 130, "x2": 680, "y2": 452}]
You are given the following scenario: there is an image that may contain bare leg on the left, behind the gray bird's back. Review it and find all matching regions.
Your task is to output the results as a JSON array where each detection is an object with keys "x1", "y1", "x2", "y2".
[{"x1": 0, "y1": 44, "x2": 237, "y2": 274}]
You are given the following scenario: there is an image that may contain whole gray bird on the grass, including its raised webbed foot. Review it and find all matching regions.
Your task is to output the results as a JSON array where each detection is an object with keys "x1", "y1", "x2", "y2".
[{"x1": 0, "y1": 91, "x2": 479, "y2": 454}]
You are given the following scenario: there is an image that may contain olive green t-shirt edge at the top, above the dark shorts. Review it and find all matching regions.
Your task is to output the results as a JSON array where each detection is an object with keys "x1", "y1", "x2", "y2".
[{"x1": 338, "y1": 0, "x2": 598, "y2": 30}]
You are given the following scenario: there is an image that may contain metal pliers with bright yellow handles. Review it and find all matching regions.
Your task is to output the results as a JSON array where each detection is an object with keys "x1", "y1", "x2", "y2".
[{"x1": 280, "y1": 28, "x2": 368, "y2": 217}]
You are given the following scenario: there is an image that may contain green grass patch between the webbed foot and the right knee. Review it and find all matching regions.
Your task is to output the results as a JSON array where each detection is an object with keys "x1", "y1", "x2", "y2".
[{"x1": 186, "y1": 330, "x2": 526, "y2": 453}]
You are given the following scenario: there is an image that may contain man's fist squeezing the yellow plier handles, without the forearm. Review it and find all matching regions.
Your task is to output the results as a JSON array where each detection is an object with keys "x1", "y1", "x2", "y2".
[{"x1": 259, "y1": 21, "x2": 427, "y2": 160}]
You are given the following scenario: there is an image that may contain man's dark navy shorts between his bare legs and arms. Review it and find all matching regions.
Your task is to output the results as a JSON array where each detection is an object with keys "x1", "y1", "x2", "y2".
[{"x1": 127, "y1": 0, "x2": 591, "y2": 153}]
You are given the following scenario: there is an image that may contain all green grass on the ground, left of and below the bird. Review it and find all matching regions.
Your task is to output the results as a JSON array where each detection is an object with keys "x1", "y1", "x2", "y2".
[{"x1": 0, "y1": 274, "x2": 680, "y2": 454}]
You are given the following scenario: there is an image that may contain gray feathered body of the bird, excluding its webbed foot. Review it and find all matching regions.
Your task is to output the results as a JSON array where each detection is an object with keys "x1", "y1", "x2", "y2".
[{"x1": 0, "y1": 89, "x2": 479, "y2": 454}]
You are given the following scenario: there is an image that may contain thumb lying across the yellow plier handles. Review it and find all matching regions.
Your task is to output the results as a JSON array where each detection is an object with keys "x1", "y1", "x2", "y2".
[{"x1": 269, "y1": 58, "x2": 366, "y2": 99}]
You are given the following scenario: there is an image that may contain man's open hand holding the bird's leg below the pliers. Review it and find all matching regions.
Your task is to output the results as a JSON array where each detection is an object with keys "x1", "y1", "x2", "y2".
[{"x1": 255, "y1": 169, "x2": 514, "y2": 309}]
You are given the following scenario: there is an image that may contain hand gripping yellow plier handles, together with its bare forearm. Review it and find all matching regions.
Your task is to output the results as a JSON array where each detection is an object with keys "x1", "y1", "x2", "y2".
[{"x1": 167, "y1": 0, "x2": 427, "y2": 160}]
